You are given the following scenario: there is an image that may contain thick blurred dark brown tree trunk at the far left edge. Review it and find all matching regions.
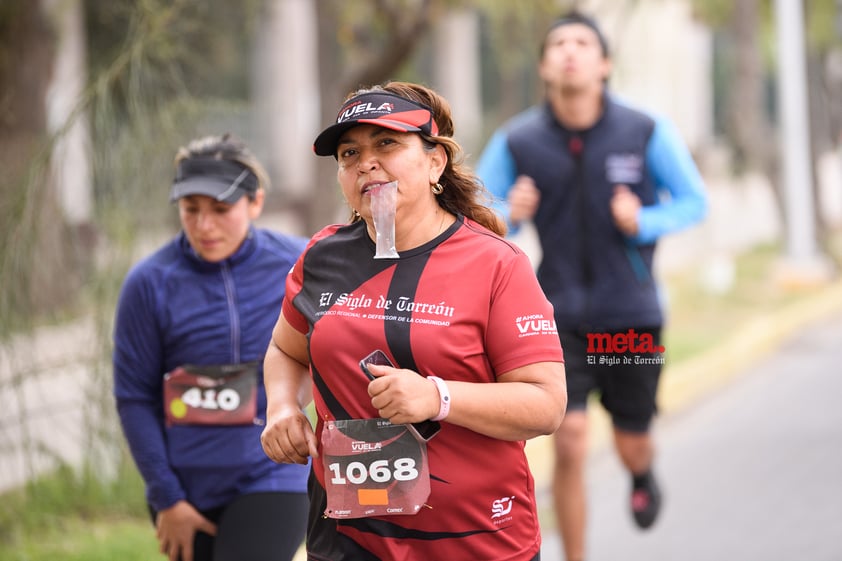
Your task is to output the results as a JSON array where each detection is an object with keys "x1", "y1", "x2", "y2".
[{"x1": 0, "y1": 0, "x2": 80, "y2": 324}]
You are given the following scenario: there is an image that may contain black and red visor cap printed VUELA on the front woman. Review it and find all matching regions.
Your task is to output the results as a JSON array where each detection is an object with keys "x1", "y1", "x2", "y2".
[{"x1": 313, "y1": 91, "x2": 439, "y2": 156}]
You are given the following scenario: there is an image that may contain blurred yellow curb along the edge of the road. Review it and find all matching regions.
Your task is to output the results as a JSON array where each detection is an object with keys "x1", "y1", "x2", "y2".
[{"x1": 526, "y1": 280, "x2": 842, "y2": 495}]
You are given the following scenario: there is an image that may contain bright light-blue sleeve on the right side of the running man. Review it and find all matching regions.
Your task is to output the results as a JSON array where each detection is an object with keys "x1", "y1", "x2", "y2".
[{"x1": 634, "y1": 115, "x2": 708, "y2": 244}]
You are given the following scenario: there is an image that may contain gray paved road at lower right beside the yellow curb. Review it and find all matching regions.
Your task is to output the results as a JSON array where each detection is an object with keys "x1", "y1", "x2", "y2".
[{"x1": 542, "y1": 317, "x2": 842, "y2": 561}]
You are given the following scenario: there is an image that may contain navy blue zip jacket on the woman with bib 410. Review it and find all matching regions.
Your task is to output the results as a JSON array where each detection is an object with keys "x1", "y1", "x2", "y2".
[{"x1": 113, "y1": 228, "x2": 309, "y2": 511}]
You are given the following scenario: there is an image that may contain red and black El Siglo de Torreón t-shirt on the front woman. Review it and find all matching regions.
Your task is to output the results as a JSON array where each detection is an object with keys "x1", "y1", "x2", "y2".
[{"x1": 283, "y1": 217, "x2": 563, "y2": 561}]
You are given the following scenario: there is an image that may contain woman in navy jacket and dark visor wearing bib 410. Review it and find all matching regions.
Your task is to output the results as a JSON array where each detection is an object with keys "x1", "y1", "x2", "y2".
[{"x1": 113, "y1": 135, "x2": 308, "y2": 561}]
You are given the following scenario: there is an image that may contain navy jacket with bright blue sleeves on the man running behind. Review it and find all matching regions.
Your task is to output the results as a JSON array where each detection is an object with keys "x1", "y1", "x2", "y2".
[{"x1": 477, "y1": 95, "x2": 707, "y2": 331}]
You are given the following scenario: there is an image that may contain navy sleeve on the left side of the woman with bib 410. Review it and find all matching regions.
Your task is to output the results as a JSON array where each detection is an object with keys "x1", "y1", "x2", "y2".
[{"x1": 113, "y1": 264, "x2": 186, "y2": 510}]
